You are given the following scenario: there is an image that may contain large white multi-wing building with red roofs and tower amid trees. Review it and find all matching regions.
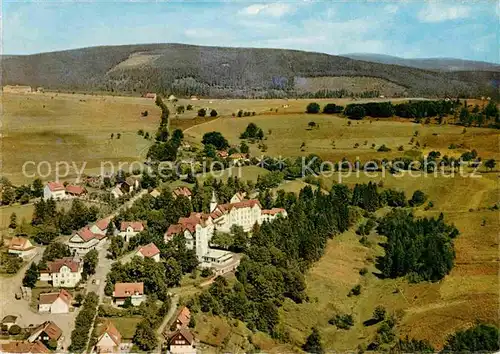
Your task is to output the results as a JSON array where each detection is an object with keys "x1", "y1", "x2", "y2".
[{"x1": 164, "y1": 193, "x2": 287, "y2": 274}]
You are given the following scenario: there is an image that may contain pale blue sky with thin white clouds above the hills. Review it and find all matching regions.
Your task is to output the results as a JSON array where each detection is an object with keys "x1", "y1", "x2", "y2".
[{"x1": 1, "y1": 0, "x2": 500, "y2": 63}]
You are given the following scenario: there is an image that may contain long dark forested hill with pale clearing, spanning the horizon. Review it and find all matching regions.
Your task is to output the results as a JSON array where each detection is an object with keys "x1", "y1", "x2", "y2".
[{"x1": 2, "y1": 44, "x2": 496, "y2": 97}]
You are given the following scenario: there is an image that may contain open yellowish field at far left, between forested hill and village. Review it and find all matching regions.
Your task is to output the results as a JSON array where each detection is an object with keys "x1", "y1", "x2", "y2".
[{"x1": 2, "y1": 93, "x2": 160, "y2": 184}]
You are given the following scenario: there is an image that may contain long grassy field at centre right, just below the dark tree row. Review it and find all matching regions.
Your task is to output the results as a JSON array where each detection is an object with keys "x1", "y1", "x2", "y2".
[{"x1": 186, "y1": 114, "x2": 500, "y2": 162}]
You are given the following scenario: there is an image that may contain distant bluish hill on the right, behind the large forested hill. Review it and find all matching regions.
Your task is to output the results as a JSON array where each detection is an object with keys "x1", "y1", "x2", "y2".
[{"x1": 342, "y1": 53, "x2": 500, "y2": 72}]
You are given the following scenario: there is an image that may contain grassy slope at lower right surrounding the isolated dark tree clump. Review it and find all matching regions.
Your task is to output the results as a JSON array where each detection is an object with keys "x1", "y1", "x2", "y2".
[{"x1": 281, "y1": 173, "x2": 500, "y2": 351}]
